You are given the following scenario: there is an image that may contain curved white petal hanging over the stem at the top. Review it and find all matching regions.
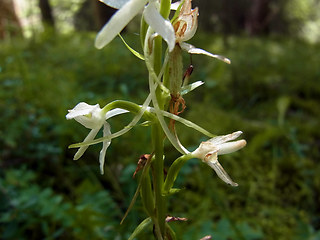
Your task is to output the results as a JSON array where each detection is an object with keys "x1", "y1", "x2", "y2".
[{"x1": 143, "y1": 1, "x2": 176, "y2": 52}]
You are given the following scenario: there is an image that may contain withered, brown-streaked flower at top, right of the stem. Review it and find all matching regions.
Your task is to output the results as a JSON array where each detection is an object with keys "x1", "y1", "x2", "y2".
[{"x1": 173, "y1": 0, "x2": 231, "y2": 64}]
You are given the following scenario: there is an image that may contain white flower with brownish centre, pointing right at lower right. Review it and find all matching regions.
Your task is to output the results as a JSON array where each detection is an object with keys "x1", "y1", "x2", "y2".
[{"x1": 191, "y1": 131, "x2": 247, "y2": 187}]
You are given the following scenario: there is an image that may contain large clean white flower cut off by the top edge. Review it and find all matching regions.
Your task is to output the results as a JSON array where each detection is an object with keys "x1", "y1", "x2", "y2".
[{"x1": 95, "y1": 0, "x2": 175, "y2": 51}]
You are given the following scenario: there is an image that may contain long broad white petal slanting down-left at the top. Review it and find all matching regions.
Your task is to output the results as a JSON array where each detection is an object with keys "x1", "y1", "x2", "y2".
[{"x1": 95, "y1": 0, "x2": 148, "y2": 49}]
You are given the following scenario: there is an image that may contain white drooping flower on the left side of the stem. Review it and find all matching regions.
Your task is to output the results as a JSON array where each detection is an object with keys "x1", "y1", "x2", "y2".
[{"x1": 66, "y1": 102, "x2": 128, "y2": 174}]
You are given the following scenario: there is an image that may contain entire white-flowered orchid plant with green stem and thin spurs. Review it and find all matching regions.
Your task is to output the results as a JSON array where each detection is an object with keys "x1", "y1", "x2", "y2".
[{"x1": 66, "y1": 0, "x2": 246, "y2": 240}]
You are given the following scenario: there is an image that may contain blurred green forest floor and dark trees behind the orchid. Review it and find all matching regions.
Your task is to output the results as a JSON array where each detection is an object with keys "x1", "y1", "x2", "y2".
[{"x1": 0, "y1": 0, "x2": 320, "y2": 240}]
